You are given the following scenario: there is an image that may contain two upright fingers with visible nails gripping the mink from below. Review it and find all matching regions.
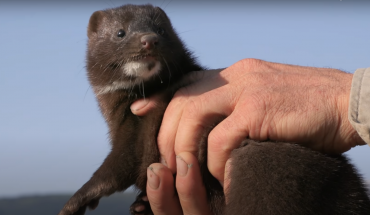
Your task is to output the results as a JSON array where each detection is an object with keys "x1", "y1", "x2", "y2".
[{"x1": 146, "y1": 152, "x2": 231, "y2": 215}]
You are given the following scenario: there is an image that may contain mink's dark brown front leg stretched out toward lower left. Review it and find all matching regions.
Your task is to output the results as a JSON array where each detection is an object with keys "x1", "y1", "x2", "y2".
[{"x1": 59, "y1": 111, "x2": 141, "y2": 215}]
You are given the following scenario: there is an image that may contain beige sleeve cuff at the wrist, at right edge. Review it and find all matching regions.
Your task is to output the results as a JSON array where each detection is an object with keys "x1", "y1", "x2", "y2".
[{"x1": 348, "y1": 68, "x2": 370, "y2": 146}]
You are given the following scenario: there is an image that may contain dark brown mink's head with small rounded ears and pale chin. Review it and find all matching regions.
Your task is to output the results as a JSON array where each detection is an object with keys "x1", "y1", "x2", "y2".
[{"x1": 87, "y1": 5, "x2": 198, "y2": 94}]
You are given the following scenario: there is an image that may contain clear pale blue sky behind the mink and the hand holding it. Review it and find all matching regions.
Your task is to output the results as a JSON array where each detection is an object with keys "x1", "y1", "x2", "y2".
[{"x1": 0, "y1": 0, "x2": 370, "y2": 197}]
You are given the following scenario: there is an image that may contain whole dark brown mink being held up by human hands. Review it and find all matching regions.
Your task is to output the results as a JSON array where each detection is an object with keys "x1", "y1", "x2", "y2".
[{"x1": 59, "y1": 5, "x2": 370, "y2": 215}]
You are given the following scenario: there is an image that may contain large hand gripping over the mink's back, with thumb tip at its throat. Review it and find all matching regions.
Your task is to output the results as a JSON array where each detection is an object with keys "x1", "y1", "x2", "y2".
[{"x1": 132, "y1": 59, "x2": 365, "y2": 183}]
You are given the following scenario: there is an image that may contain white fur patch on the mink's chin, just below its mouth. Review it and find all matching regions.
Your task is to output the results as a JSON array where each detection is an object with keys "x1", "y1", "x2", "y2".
[{"x1": 123, "y1": 61, "x2": 161, "y2": 80}]
